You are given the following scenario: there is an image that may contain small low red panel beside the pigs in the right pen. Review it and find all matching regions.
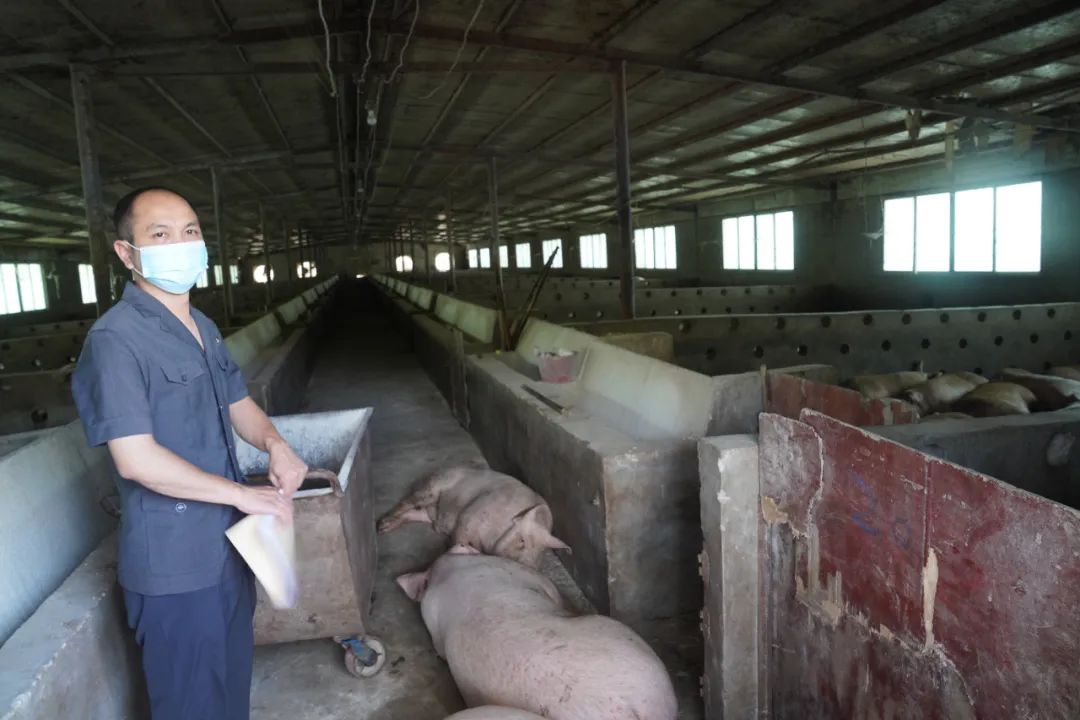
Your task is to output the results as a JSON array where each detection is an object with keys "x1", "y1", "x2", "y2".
[{"x1": 765, "y1": 372, "x2": 919, "y2": 427}]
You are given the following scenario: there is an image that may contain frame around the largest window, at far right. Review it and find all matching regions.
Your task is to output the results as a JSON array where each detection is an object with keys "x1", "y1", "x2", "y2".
[{"x1": 875, "y1": 175, "x2": 1047, "y2": 277}]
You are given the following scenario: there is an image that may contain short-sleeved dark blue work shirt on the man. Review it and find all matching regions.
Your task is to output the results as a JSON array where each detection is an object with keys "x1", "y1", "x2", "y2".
[{"x1": 71, "y1": 283, "x2": 247, "y2": 595}]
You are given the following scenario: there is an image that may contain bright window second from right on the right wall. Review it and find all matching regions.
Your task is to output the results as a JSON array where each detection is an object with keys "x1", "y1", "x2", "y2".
[{"x1": 721, "y1": 210, "x2": 795, "y2": 270}]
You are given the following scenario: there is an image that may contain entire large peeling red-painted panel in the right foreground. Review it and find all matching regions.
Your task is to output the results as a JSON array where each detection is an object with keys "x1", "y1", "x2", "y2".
[{"x1": 761, "y1": 411, "x2": 1080, "y2": 719}]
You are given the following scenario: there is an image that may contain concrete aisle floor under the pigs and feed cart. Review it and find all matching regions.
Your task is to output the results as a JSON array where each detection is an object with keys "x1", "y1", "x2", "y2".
[{"x1": 252, "y1": 287, "x2": 703, "y2": 720}]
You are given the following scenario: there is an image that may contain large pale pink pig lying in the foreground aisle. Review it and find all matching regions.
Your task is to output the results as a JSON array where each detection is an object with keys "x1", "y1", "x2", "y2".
[{"x1": 397, "y1": 545, "x2": 677, "y2": 720}]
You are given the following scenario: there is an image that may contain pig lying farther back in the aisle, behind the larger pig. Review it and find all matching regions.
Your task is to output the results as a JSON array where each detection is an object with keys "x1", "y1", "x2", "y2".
[{"x1": 379, "y1": 465, "x2": 570, "y2": 568}]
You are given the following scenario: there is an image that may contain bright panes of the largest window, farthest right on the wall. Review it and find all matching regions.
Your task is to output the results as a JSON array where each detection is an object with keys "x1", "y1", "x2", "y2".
[{"x1": 881, "y1": 182, "x2": 1042, "y2": 272}]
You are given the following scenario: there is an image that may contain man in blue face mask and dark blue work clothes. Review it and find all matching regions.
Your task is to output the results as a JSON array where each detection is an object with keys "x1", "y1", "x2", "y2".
[{"x1": 71, "y1": 188, "x2": 307, "y2": 720}]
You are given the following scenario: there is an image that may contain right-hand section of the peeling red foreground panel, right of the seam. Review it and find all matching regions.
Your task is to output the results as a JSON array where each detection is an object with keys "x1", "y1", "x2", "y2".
[{"x1": 928, "y1": 460, "x2": 1080, "y2": 718}]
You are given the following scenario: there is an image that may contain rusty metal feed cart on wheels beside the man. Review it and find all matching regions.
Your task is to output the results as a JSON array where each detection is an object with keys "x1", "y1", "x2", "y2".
[{"x1": 237, "y1": 408, "x2": 386, "y2": 677}]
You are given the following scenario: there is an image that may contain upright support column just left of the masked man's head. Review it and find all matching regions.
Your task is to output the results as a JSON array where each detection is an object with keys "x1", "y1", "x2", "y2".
[{"x1": 70, "y1": 65, "x2": 112, "y2": 317}]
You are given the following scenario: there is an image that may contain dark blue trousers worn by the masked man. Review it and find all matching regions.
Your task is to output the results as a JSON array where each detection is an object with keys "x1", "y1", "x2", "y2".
[{"x1": 124, "y1": 568, "x2": 255, "y2": 720}]
